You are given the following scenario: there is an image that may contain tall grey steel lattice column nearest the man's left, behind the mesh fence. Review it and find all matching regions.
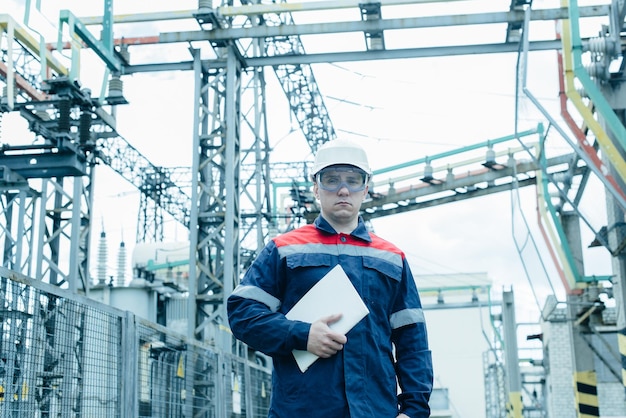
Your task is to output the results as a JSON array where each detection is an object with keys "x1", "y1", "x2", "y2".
[{"x1": 187, "y1": 46, "x2": 241, "y2": 416}]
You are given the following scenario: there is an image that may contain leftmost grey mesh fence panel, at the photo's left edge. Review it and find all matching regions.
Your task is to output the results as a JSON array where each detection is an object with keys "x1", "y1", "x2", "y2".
[{"x1": 0, "y1": 276, "x2": 120, "y2": 418}]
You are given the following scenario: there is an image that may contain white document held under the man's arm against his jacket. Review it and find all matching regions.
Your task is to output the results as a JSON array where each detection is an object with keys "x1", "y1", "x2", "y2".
[{"x1": 285, "y1": 264, "x2": 369, "y2": 373}]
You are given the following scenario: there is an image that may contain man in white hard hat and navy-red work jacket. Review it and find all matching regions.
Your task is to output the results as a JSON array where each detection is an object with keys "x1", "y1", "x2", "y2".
[{"x1": 227, "y1": 140, "x2": 433, "y2": 418}]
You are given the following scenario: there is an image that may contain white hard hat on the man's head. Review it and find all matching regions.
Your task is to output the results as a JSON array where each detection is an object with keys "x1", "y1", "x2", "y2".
[{"x1": 312, "y1": 139, "x2": 372, "y2": 176}]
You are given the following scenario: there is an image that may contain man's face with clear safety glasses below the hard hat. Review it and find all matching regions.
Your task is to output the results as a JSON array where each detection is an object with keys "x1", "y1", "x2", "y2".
[{"x1": 314, "y1": 165, "x2": 367, "y2": 225}]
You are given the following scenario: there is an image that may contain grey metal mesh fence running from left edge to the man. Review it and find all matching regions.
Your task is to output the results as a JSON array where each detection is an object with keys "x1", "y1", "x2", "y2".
[{"x1": 0, "y1": 268, "x2": 271, "y2": 418}]
